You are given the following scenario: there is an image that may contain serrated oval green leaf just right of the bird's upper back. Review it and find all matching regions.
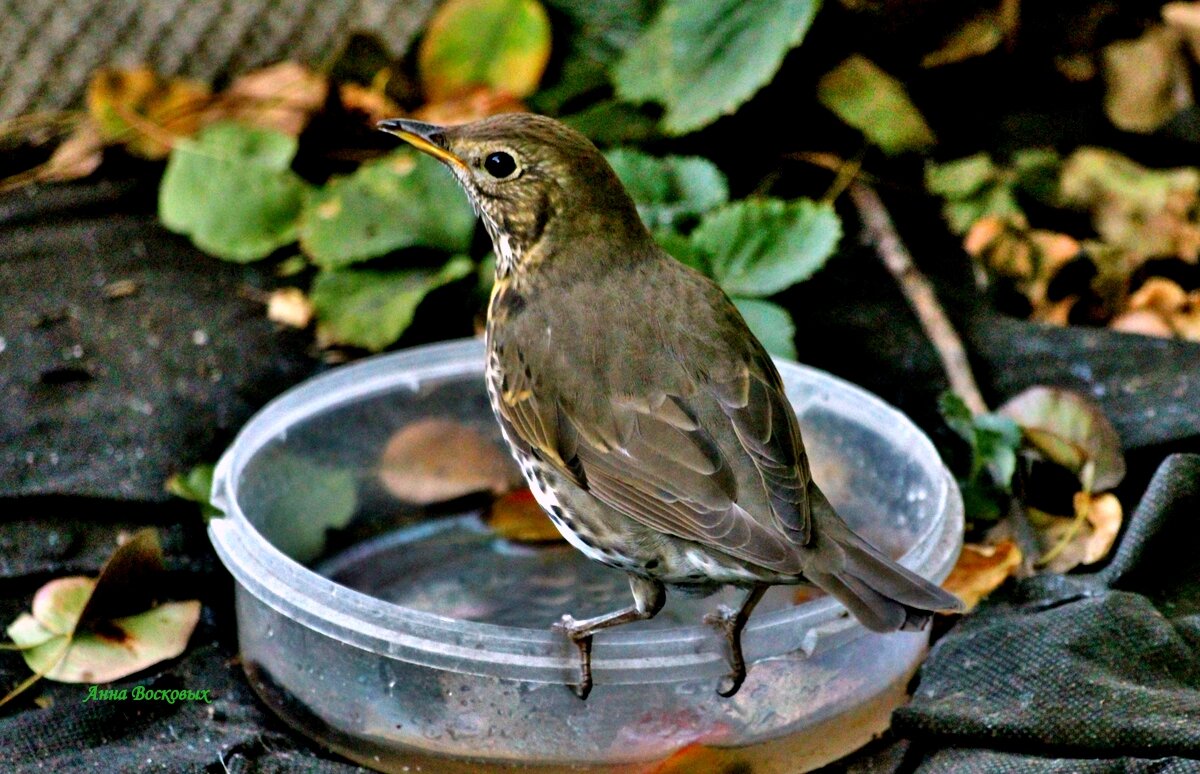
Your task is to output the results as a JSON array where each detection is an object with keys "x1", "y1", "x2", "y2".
[{"x1": 691, "y1": 199, "x2": 841, "y2": 296}]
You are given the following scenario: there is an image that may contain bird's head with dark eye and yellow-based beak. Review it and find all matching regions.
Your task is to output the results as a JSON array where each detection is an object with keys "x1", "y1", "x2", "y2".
[{"x1": 378, "y1": 113, "x2": 648, "y2": 272}]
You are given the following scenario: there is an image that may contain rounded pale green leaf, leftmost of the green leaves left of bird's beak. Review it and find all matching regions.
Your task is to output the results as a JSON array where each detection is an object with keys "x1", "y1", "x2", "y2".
[{"x1": 158, "y1": 122, "x2": 307, "y2": 262}]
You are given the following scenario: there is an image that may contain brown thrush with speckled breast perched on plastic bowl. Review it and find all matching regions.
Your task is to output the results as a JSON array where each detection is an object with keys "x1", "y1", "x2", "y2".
[{"x1": 379, "y1": 114, "x2": 961, "y2": 697}]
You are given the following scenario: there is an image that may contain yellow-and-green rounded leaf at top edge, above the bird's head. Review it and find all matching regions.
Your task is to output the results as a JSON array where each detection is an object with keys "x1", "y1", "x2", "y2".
[{"x1": 416, "y1": 0, "x2": 550, "y2": 102}]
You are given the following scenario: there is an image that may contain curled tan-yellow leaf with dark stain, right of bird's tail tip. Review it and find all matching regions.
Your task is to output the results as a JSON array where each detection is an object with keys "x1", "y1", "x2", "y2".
[{"x1": 1028, "y1": 492, "x2": 1123, "y2": 572}]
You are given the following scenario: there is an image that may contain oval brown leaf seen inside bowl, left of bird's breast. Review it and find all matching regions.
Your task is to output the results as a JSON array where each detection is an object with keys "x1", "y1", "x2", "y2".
[{"x1": 378, "y1": 416, "x2": 521, "y2": 505}]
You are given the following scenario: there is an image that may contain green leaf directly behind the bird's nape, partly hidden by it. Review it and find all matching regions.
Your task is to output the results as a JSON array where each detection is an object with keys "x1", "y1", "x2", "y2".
[{"x1": 605, "y1": 148, "x2": 730, "y2": 230}]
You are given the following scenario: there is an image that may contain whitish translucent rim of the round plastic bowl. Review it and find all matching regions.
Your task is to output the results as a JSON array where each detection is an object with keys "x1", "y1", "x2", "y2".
[{"x1": 209, "y1": 338, "x2": 962, "y2": 684}]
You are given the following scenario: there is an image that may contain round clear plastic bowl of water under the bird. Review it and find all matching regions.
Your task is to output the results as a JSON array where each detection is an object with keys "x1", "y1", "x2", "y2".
[{"x1": 209, "y1": 340, "x2": 962, "y2": 774}]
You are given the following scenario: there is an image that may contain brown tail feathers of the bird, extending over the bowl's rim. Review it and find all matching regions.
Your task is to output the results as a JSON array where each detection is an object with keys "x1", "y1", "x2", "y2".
[{"x1": 805, "y1": 486, "x2": 962, "y2": 631}]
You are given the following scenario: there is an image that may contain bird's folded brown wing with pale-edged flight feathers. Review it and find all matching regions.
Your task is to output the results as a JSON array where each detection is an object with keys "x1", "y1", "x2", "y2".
[{"x1": 499, "y1": 319, "x2": 810, "y2": 574}]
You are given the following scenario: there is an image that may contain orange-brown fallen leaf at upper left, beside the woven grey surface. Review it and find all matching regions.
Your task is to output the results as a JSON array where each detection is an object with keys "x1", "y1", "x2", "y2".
[{"x1": 88, "y1": 67, "x2": 211, "y2": 158}]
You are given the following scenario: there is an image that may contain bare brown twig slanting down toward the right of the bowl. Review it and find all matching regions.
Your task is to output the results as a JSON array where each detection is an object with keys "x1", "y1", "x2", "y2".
[{"x1": 850, "y1": 181, "x2": 988, "y2": 414}]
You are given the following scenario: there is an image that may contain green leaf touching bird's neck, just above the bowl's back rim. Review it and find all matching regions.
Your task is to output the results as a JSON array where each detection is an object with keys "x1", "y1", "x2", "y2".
[{"x1": 311, "y1": 256, "x2": 474, "y2": 352}]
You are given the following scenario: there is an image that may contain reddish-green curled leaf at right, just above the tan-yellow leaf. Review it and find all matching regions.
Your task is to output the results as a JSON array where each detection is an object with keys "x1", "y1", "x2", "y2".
[{"x1": 998, "y1": 386, "x2": 1126, "y2": 492}]
